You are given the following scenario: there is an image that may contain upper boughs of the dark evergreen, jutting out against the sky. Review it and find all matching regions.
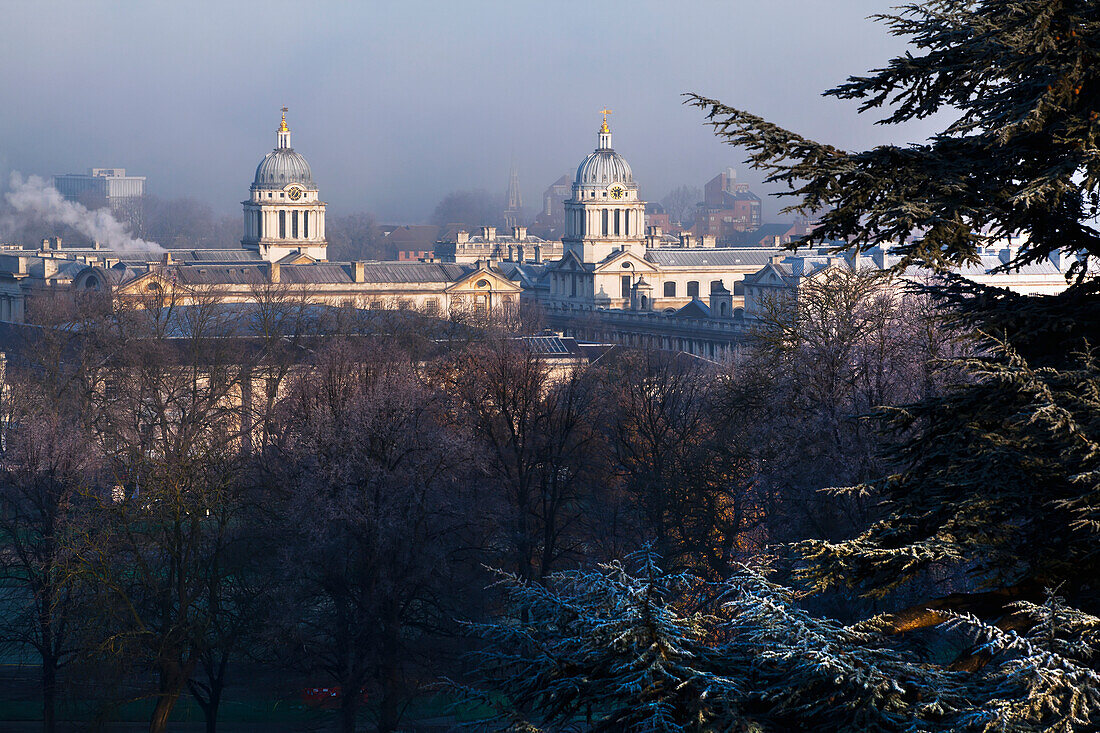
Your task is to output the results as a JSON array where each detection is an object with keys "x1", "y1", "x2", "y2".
[{"x1": 689, "y1": 0, "x2": 1100, "y2": 274}]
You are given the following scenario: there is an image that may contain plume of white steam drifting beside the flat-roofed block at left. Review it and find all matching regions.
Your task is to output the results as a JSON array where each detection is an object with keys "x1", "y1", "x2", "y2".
[{"x1": 4, "y1": 172, "x2": 164, "y2": 252}]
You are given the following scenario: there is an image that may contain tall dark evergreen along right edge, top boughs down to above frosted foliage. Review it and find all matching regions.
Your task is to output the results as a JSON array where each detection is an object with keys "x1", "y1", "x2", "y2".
[{"x1": 690, "y1": 0, "x2": 1100, "y2": 629}]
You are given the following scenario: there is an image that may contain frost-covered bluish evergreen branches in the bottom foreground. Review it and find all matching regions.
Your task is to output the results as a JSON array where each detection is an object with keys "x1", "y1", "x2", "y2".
[{"x1": 465, "y1": 554, "x2": 1100, "y2": 733}]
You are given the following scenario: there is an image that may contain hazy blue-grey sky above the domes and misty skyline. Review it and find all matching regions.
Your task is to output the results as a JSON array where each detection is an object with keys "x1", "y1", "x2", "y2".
[{"x1": 0, "y1": 0, "x2": 946, "y2": 222}]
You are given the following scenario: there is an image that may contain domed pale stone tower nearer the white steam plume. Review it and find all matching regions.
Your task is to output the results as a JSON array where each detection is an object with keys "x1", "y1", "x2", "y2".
[{"x1": 241, "y1": 107, "x2": 328, "y2": 262}]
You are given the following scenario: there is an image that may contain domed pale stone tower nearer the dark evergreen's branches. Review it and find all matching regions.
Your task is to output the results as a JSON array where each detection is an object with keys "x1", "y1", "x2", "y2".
[{"x1": 562, "y1": 109, "x2": 646, "y2": 263}]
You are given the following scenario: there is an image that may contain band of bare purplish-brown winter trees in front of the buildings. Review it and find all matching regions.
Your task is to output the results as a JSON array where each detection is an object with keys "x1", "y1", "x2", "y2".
[{"x1": 0, "y1": 268, "x2": 958, "y2": 731}]
